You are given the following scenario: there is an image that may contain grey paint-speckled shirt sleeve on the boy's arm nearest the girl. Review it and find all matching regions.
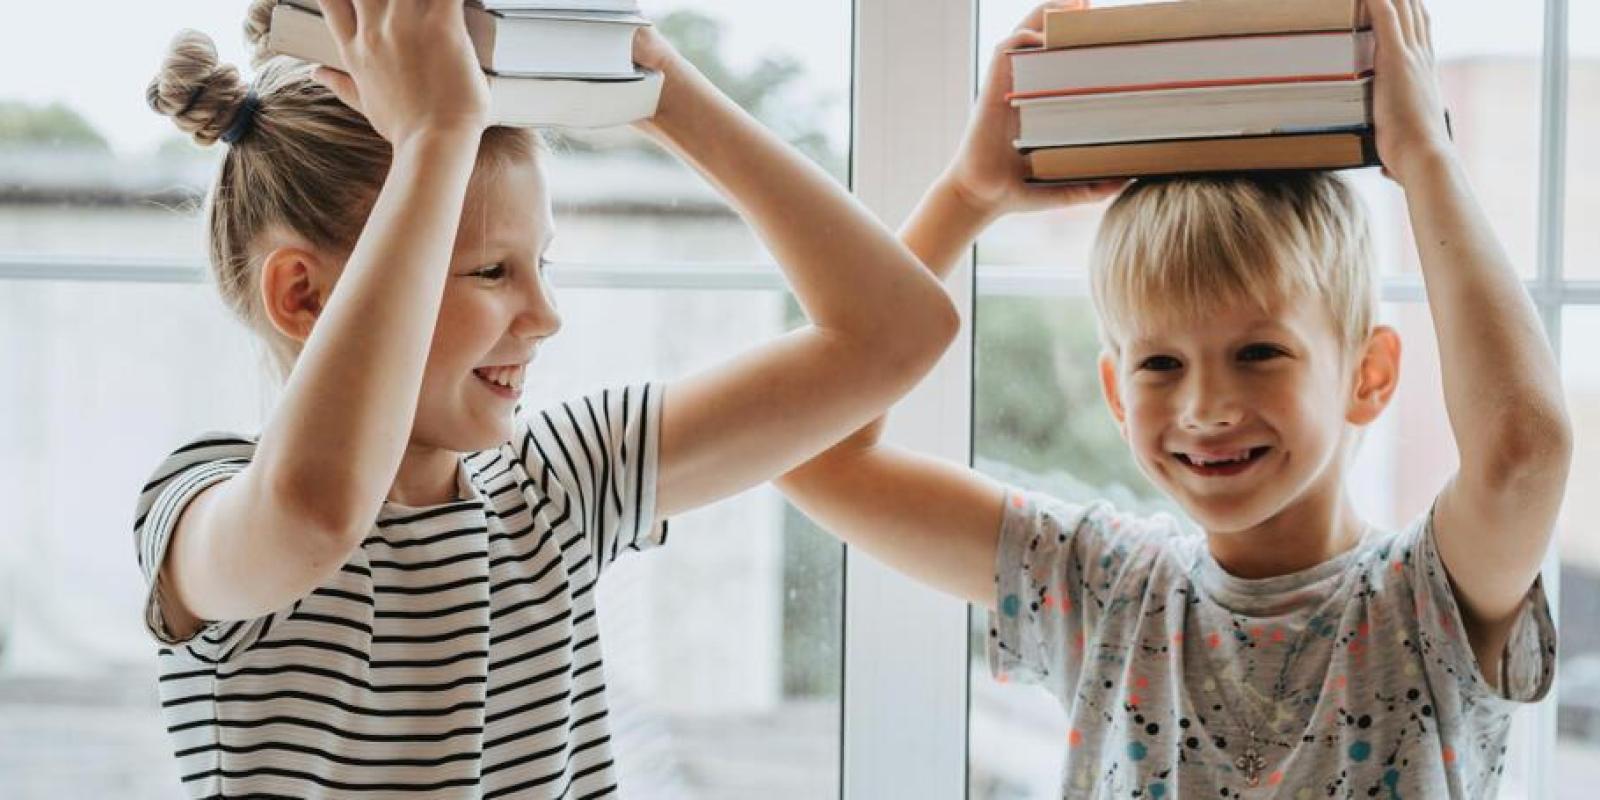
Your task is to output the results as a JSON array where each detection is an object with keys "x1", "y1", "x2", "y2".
[{"x1": 987, "y1": 490, "x2": 1149, "y2": 698}]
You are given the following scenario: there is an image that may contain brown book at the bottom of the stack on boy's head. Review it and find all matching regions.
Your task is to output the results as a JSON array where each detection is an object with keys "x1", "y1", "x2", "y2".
[{"x1": 1027, "y1": 130, "x2": 1379, "y2": 182}]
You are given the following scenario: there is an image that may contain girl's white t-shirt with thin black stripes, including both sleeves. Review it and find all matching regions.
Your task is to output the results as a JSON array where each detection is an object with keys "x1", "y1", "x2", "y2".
[{"x1": 134, "y1": 386, "x2": 666, "y2": 798}]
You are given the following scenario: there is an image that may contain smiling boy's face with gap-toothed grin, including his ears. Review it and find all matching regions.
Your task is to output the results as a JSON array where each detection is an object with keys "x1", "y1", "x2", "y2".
[{"x1": 1101, "y1": 292, "x2": 1397, "y2": 533}]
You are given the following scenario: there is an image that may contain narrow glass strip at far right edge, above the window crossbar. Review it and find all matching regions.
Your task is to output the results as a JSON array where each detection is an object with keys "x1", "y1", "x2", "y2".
[{"x1": 1565, "y1": 0, "x2": 1600, "y2": 280}]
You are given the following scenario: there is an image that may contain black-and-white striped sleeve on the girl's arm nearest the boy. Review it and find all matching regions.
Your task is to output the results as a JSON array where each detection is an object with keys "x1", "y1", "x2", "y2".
[{"x1": 518, "y1": 384, "x2": 667, "y2": 570}]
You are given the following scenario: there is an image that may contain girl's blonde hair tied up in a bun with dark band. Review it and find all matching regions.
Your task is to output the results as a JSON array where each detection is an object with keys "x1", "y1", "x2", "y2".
[{"x1": 146, "y1": 0, "x2": 541, "y2": 378}]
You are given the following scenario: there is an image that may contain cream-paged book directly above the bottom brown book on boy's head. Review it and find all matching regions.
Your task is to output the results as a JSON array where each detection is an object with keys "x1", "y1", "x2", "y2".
[{"x1": 1013, "y1": 78, "x2": 1373, "y2": 150}]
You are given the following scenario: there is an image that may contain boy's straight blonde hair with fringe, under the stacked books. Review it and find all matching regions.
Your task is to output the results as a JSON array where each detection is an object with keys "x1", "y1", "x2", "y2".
[{"x1": 1090, "y1": 173, "x2": 1378, "y2": 363}]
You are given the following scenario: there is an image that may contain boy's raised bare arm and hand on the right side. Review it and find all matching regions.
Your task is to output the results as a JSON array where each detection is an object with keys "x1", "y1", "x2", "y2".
[{"x1": 1370, "y1": 0, "x2": 1573, "y2": 685}]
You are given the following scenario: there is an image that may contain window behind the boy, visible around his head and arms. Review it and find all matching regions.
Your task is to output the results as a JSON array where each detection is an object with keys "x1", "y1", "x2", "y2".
[{"x1": 970, "y1": 0, "x2": 1580, "y2": 800}]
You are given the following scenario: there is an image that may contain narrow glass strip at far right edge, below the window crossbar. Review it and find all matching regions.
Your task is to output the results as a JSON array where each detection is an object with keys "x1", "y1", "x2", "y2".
[{"x1": 1552, "y1": 307, "x2": 1600, "y2": 790}]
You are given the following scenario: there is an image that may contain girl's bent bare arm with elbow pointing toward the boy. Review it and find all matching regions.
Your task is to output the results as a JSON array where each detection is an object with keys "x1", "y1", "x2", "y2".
[{"x1": 635, "y1": 29, "x2": 958, "y2": 517}]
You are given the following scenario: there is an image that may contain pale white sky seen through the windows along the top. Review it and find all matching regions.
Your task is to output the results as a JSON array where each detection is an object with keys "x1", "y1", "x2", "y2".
[{"x1": 0, "y1": 0, "x2": 1600, "y2": 154}]
